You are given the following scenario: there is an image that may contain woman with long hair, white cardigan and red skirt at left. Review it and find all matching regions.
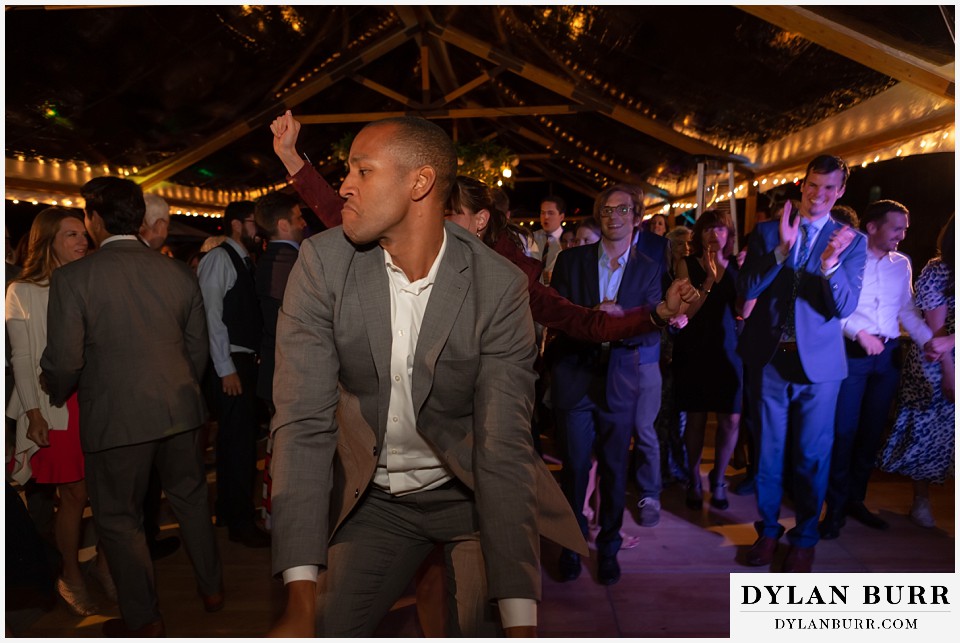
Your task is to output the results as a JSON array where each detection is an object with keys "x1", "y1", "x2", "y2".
[{"x1": 6, "y1": 208, "x2": 112, "y2": 616}]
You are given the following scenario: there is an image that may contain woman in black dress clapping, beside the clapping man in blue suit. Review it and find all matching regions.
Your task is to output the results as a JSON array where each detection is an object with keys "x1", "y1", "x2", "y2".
[{"x1": 673, "y1": 210, "x2": 743, "y2": 510}]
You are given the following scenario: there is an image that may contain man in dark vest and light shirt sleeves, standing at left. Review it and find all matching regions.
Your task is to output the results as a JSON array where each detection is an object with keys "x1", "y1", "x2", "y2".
[{"x1": 197, "y1": 201, "x2": 270, "y2": 547}]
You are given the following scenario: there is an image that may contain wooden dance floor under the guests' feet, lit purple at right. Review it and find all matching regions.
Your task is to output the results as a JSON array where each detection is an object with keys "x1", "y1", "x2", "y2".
[{"x1": 6, "y1": 430, "x2": 955, "y2": 638}]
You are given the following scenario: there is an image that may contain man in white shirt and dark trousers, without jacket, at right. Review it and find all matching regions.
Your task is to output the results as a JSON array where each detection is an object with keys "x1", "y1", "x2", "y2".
[{"x1": 820, "y1": 200, "x2": 933, "y2": 540}]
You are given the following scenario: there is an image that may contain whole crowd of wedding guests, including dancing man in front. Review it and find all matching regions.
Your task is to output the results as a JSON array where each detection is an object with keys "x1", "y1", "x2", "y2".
[{"x1": 6, "y1": 111, "x2": 954, "y2": 636}]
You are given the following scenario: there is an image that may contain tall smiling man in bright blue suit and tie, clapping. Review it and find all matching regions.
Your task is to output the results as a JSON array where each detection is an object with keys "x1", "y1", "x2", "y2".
[{"x1": 738, "y1": 155, "x2": 866, "y2": 572}]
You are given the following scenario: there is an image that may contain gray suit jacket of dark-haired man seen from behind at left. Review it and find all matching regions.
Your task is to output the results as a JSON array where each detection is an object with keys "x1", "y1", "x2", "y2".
[{"x1": 40, "y1": 240, "x2": 209, "y2": 452}]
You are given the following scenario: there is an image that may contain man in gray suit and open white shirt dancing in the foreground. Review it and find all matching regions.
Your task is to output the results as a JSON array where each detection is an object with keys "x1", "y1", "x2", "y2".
[{"x1": 272, "y1": 118, "x2": 586, "y2": 636}]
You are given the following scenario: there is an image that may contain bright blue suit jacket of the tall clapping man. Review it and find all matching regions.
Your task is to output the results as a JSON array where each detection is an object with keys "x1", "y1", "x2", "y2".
[{"x1": 737, "y1": 219, "x2": 867, "y2": 382}]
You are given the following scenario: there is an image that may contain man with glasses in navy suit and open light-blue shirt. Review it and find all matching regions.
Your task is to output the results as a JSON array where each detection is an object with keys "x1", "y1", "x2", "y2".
[{"x1": 548, "y1": 185, "x2": 666, "y2": 585}]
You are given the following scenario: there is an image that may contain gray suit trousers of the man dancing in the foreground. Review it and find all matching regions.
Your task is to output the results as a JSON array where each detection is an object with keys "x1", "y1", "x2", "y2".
[{"x1": 317, "y1": 481, "x2": 502, "y2": 637}]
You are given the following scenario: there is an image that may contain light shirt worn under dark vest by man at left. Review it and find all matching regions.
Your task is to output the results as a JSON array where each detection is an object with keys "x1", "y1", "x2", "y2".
[{"x1": 197, "y1": 237, "x2": 256, "y2": 377}]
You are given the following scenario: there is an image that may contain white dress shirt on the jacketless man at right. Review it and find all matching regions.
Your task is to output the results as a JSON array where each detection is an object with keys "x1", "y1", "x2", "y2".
[{"x1": 841, "y1": 250, "x2": 933, "y2": 346}]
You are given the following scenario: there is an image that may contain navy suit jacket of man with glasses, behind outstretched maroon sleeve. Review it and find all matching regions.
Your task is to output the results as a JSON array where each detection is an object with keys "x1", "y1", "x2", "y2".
[{"x1": 547, "y1": 239, "x2": 667, "y2": 409}]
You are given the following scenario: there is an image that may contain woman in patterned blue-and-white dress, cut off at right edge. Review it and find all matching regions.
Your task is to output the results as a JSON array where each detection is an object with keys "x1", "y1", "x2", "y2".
[{"x1": 878, "y1": 216, "x2": 955, "y2": 528}]
